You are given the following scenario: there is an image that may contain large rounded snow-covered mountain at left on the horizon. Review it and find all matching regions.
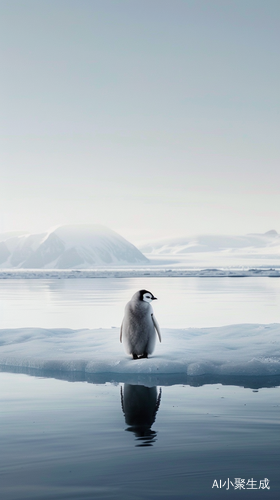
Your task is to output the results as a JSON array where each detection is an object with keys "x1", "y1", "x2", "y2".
[{"x1": 0, "y1": 224, "x2": 149, "y2": 269}]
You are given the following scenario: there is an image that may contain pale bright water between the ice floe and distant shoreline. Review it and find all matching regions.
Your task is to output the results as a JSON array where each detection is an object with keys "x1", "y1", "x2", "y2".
[{"x1": 0, "y1": 278, "x2": 280, "y2": 329}]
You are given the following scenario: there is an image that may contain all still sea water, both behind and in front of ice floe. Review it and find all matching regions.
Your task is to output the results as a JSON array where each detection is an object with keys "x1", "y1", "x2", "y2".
[{"x1": 0, "y1": 278, "x2": 280, "y2": 500}]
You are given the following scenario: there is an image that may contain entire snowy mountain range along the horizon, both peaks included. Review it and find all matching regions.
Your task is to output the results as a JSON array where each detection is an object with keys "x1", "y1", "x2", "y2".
[{"x1": 0, "y1": 228, "x2": 280, "y2": 269}]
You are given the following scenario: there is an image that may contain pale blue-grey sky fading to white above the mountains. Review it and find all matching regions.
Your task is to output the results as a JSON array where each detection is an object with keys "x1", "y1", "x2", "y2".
[{"x1": 0, "y1": 0, "x2": 280, "y2": 243}]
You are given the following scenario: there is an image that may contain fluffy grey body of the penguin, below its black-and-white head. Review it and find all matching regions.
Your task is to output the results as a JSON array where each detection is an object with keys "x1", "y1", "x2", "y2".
[{"x1": 122, "y1": 307, "x2": 156, "y2": 356}]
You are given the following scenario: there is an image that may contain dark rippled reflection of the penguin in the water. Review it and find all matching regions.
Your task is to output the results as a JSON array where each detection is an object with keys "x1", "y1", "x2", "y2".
[{"x1": 121, "y1": 384, "x2": 161, "y2": 446}]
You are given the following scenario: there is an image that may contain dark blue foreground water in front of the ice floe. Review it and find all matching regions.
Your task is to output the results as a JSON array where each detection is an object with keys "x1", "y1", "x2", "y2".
[{"x1": 0, "y1": 373, "x2": 280, "y2": 500}]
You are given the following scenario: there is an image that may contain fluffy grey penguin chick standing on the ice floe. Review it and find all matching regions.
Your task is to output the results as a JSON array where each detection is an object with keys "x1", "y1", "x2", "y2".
[{"x1": 120, "y1": 290, "x2": 161, "y2": 359}]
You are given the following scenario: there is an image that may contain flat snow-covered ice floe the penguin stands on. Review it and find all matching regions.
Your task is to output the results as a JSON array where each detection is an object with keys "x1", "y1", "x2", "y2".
[{"x1": 0, "y1": 323, "x2": 280, "y2": 378}]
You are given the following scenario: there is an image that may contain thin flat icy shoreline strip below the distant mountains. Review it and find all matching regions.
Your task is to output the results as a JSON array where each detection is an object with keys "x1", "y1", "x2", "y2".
[{"x1": 0, "y1": 267, "x2": 280, "y2": 279}]
